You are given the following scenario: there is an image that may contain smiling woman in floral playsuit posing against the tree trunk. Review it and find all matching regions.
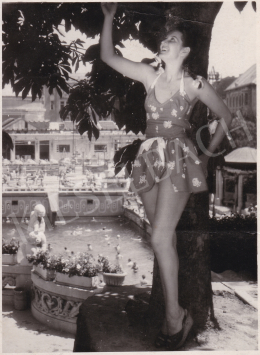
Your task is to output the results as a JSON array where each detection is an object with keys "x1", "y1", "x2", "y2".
[{"x1": 101, "y1": 3, "x2": 231, "y2": 350}]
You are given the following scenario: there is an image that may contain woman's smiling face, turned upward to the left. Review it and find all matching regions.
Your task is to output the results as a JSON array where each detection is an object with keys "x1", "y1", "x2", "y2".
[{"x1": 159, "y1": 31, "x2": 187, "y2": 60}]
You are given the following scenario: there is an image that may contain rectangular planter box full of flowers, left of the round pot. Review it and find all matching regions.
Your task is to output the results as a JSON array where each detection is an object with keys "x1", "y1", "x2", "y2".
[{"x1": 55, "y1": 251, "x2": 99, "y2": 289}]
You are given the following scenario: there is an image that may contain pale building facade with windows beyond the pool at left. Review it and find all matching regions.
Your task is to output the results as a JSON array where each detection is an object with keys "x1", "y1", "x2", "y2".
[{"x1": 2, "y1": 77, "x2": 143, "y2": 162}]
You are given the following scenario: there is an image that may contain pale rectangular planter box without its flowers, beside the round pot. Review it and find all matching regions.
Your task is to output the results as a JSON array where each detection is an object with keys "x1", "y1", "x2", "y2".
[{"x1": 56, "y1": 272, "x2": 99, "y2": 289}]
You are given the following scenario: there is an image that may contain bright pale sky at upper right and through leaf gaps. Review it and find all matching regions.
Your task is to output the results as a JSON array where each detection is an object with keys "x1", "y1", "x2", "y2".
[{"x1": 3, "y1": 1, "x2": 257, "y2": 95}]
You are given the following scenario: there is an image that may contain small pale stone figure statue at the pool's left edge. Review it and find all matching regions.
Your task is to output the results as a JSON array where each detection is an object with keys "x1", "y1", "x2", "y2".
[{"x1": 18, "y1": 203, "x2": 47, "y2": 265}]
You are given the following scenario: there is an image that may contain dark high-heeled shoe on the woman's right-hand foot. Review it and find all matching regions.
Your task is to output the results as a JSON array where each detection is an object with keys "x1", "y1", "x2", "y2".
[{"x1": 166, "y1": 309, "x2": 193, "y2": 351}]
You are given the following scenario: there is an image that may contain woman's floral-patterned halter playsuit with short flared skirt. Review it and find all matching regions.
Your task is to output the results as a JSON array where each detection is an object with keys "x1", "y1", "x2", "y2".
[{"x1": 130, "y1": 73, "x2": 207, "y2": 194}]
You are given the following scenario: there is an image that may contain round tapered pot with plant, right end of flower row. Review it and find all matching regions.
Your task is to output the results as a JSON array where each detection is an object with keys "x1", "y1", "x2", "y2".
[{"x1": 98, "y1": 255, "x2": 127, "y2": 286}]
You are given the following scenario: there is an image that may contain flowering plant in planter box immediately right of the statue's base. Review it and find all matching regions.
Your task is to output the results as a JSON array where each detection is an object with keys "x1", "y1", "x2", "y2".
[{"x1": 26, "y1": 250, "x2": 56, "y2": 281}]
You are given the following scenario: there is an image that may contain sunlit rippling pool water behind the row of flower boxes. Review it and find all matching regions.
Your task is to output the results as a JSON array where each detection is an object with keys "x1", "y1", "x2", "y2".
[{"x1": 2, "y1": 217, "x2": 154, "y2": 285}]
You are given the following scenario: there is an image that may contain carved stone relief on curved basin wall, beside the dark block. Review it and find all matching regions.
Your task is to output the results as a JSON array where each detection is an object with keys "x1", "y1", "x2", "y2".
[{"x1": 32, "y1": 284, "x2": 82, "y2": 319}]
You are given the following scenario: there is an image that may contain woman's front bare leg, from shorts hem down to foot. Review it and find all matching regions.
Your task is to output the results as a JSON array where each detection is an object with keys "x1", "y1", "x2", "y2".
[{"x1": 151, "y1": 178, "x2": 190, "y2": 335}]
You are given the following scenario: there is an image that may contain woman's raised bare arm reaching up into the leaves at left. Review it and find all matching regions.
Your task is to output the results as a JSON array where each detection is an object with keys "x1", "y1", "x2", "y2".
[{"x1": 100, "y1": 2, "x2": 155, "y2": 89}]
